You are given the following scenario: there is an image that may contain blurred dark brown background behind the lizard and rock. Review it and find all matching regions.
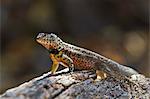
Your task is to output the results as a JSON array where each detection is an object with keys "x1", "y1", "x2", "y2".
[{"x1": 0, "y1": 0, "x2": 150, "y2": 93}]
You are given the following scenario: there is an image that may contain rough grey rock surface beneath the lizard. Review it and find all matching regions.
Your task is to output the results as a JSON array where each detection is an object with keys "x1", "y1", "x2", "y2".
[{"x1": 0, "y1": 69, "x2": 150, "y2": 99}]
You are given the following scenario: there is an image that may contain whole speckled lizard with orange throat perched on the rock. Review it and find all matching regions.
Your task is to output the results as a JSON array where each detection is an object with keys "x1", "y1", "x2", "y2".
[{"x1": 36, "y1": 33, "x2": 138, "y2": 79}]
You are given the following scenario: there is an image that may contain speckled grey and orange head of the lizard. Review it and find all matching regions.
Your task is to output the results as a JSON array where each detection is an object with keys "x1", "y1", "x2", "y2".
[{"x1": 36, "y1": 33, "x2": 63, "y2": 50}]
